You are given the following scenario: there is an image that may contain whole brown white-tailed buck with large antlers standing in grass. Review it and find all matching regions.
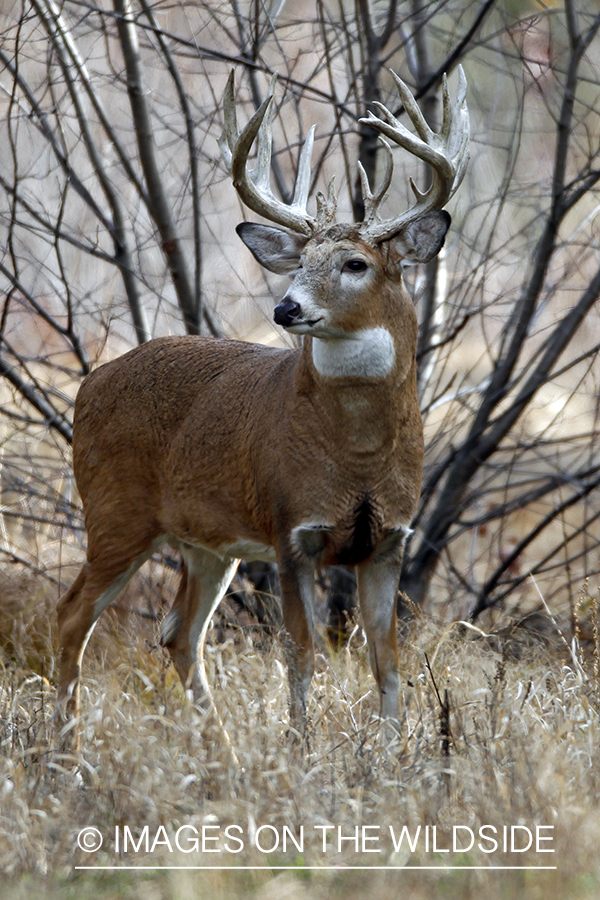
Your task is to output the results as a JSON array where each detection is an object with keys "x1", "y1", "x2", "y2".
[{"x1": 57, "y1": 69, "x2": 469, "y2": 734}]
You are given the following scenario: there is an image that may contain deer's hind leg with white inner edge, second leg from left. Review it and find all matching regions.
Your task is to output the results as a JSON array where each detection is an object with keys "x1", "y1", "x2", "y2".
[{"x1": 160, "y1": 546, "x2": 239, "y2": 707}]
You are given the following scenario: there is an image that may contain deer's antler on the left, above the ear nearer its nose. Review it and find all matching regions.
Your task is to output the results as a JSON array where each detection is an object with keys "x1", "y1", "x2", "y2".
[{"x1": 219, "y1": 72, "x2": 336, "y2": 235}]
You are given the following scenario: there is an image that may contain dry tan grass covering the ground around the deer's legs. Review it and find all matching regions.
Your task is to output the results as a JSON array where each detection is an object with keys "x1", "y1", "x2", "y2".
[{"x1": 0, "y1": 577, "x2": 600, "y2": 900}]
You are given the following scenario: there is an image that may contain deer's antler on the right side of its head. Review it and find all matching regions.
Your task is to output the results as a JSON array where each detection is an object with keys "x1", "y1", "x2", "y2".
[{"x1": 358, "y1": 66, "x2": 469, "y2": 244}]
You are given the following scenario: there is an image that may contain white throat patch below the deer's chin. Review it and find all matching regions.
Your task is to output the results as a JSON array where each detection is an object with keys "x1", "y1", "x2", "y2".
[{"x1": 312, "y1": 328, "x2": 396, "y2": 378}]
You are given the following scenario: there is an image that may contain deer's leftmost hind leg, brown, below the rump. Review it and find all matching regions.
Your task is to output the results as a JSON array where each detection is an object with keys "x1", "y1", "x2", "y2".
[{"x1": 57, "y1": 541, "x2": 159, "y2": 719}]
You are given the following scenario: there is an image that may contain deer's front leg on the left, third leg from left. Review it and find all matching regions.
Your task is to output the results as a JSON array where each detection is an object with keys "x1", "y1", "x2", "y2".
[{"x1": 278, "y1": 558, "x2": 315, "y2": 735}]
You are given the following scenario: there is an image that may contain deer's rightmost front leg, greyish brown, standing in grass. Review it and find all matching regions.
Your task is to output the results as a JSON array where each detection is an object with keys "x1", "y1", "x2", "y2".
[{"x1": 357, "y1": 557, "x2": 400, "y2": 722}]
